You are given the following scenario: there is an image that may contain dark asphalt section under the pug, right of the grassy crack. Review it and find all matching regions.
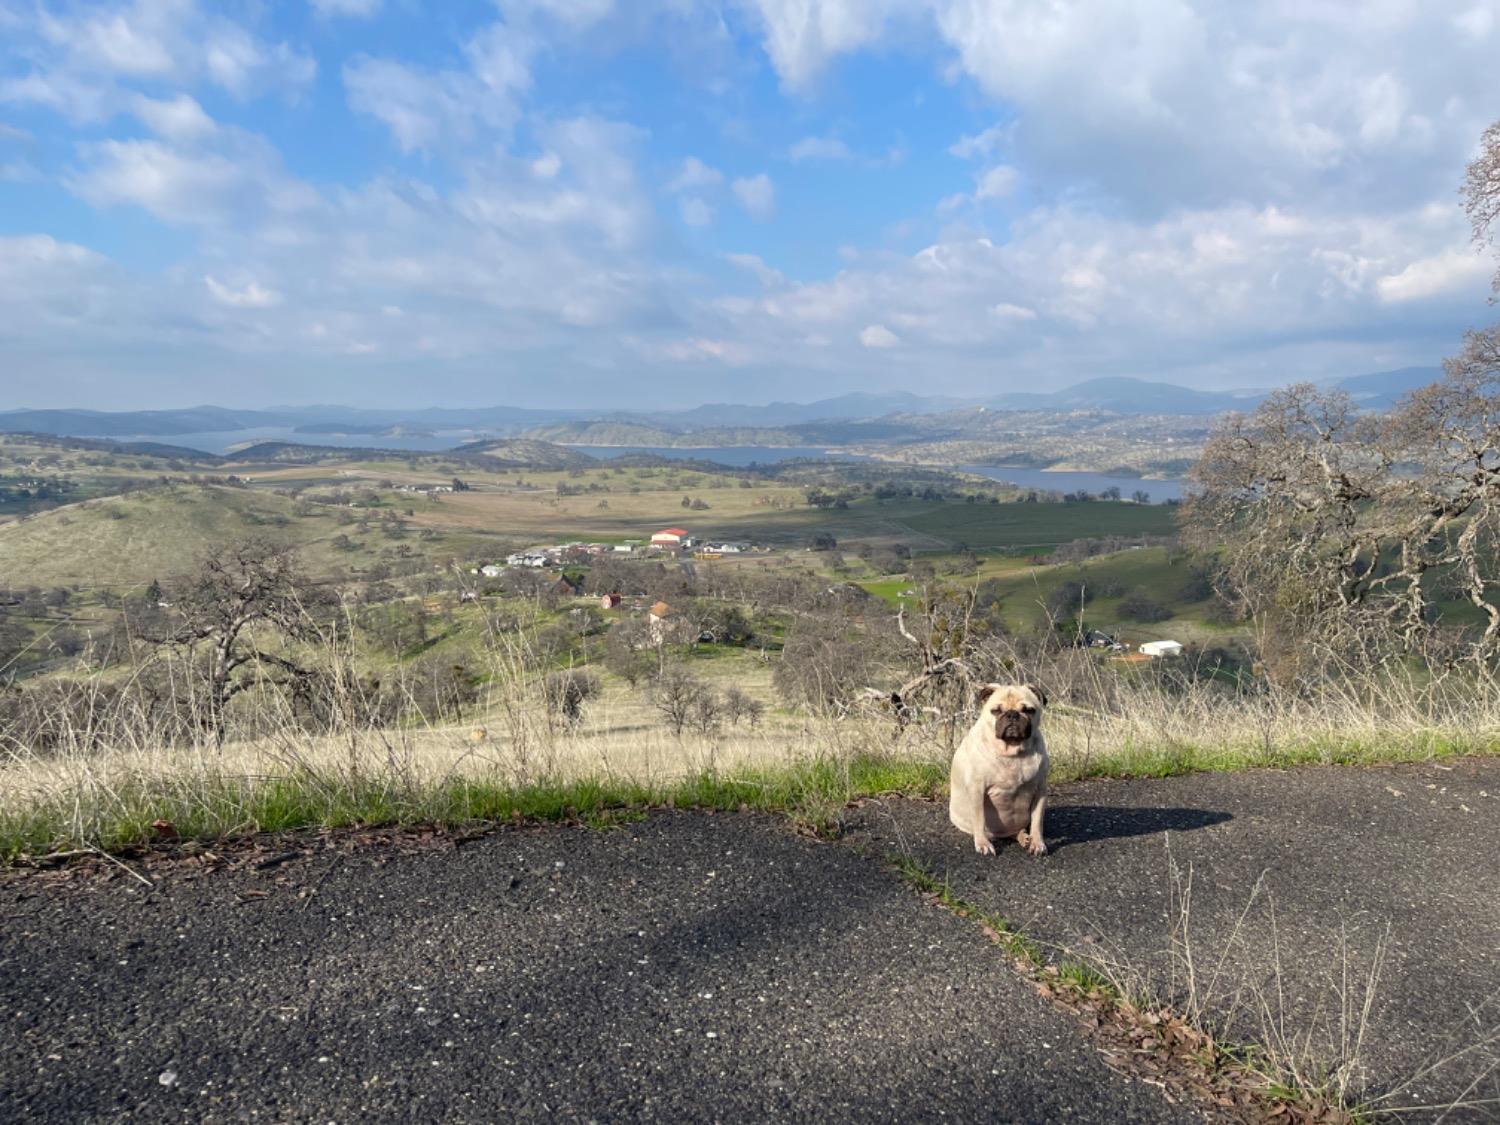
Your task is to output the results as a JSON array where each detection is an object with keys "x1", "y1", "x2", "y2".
[{"x1": 855, "y1": 759, "x2": 1500, "y2": 1122}]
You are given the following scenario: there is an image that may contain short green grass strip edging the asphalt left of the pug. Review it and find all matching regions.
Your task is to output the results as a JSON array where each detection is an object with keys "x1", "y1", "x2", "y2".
[{"x1": 0, "y1": 756, "x2": 947, "y2": 863}]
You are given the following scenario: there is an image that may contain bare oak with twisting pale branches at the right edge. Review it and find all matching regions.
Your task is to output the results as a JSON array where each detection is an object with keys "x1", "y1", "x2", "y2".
[{"x1": 1182, "y1": 358, "x2": 1500, "y2": 675}]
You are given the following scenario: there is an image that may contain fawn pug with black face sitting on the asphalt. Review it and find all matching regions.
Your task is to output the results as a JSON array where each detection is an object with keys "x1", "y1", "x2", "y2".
[{"x1": 948, "y1": 684, "x2": 1049, "y2": 855}]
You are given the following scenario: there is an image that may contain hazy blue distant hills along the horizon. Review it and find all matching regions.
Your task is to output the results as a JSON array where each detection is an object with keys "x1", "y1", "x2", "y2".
[{"x1": 0, "y1": 368, "x2": 1442, "y2": 446}]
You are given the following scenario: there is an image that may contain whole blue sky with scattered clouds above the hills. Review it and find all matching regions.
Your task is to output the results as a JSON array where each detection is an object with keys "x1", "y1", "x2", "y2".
[{"x1": 0, "y1": 0, "x2": 1500, "y2": 410}]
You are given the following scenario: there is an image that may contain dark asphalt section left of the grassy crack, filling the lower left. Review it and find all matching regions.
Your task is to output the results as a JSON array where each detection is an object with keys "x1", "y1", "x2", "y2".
[{"x1": 0, "y1": 807, "x2": 1196, "y2": 1124}]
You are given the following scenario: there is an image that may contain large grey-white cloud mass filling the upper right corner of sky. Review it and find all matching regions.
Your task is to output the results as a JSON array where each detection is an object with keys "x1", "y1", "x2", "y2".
[{"x1": 743, "y1": 0, "x2": 1500, "y2": 215}]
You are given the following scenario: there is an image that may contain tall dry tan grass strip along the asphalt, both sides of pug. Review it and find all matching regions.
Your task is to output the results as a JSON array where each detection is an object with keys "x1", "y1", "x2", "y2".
[{"x1": 0, "y1": 651, "x2": 1500, "y2": 854}]
